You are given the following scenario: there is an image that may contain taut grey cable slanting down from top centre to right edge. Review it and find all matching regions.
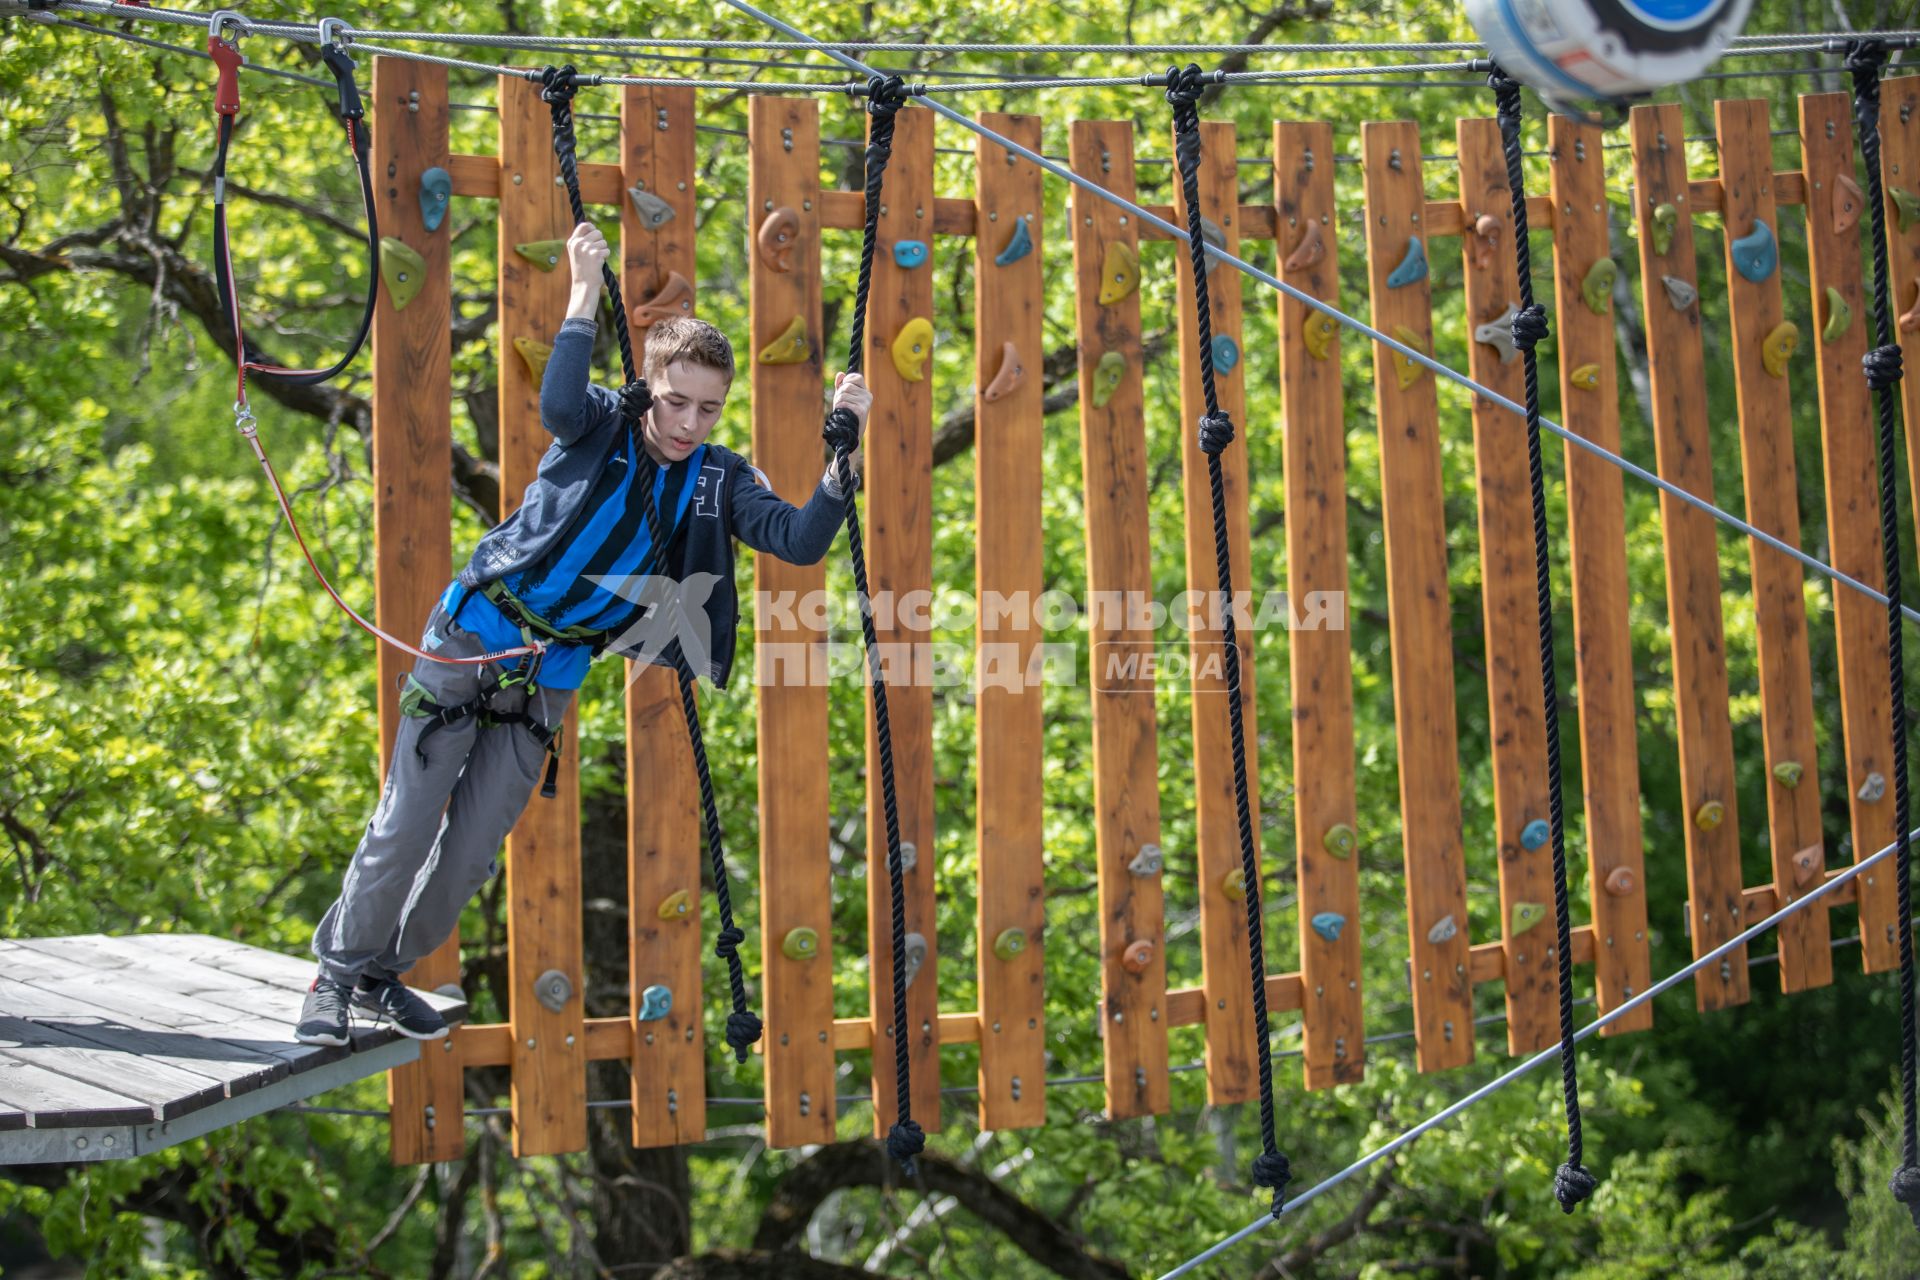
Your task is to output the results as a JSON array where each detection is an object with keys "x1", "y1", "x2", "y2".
[{"x1": 726, "y1": 0, "x2": 1920, "y2": 640}]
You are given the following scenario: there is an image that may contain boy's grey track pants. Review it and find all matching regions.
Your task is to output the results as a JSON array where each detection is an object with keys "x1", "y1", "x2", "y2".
[{"x1": 313, "y1": 604, "x2": 574, "y2": 986}]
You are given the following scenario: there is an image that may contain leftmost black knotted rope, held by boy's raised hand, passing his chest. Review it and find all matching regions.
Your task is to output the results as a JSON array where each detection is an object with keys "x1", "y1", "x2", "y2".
[{"x1": 540, "y1": 65, "x2": 760, "y2": 1063}]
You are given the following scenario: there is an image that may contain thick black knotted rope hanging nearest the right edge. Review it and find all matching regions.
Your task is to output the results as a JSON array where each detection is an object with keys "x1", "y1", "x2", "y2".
[{"x1": 1847, "y1": 40, "x2": 1920, "y2": 1226}]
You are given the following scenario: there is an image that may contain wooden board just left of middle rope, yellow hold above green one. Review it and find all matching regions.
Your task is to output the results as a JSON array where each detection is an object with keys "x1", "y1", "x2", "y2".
[{"x1": 1069, "y1": 121, "x2": 1167, "y2": 1119}]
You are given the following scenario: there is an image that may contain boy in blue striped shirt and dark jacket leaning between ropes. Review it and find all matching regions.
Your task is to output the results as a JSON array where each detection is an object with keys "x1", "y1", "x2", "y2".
[{"x1": 296, "y1": 223, "x2": 872, "y2": 1044}]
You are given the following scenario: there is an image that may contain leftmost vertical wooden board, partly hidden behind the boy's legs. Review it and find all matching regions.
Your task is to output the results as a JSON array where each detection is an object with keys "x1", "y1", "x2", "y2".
[{"x1": 369, "y1": 58, "x2": 467, "y2": 1165}]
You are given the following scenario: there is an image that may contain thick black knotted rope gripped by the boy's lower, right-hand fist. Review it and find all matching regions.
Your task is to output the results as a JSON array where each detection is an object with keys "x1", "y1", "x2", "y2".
[{"x1": 820, "y1": 75, "x2": 927, "y2": 1176}]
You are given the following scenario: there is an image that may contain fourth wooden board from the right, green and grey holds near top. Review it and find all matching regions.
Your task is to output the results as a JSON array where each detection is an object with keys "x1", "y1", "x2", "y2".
[{"x1": 1630, "y1": 104, "x2": 1747, "y2": 1011}]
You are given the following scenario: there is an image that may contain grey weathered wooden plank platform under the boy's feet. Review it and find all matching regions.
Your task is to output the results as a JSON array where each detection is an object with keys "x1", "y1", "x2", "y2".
[{"x1": 0, "y1": 933, "x2": 467, "y2": 1165}]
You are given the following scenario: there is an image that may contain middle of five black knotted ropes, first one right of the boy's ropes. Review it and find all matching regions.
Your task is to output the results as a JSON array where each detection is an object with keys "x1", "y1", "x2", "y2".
[{"x1": 1167, "y1": 63, "x2": 1292, "y2": 1217}]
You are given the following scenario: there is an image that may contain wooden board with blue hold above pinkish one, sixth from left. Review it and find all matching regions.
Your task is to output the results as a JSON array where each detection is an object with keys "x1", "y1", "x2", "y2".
[{"x1": 973, "y1": 111, "x2": 1046, "y2": 1128}]
